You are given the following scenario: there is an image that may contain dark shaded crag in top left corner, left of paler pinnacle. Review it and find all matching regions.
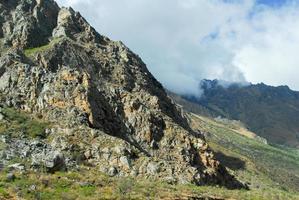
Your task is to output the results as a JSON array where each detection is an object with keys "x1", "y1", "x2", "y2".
[{"x1": 0, "y1": 0, "x2": 60, "y2": 48}]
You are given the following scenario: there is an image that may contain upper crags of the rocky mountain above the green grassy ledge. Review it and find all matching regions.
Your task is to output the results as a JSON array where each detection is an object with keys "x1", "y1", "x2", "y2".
[{"x1": 0, "y1": 0, "x2": 108, "y2": 48}]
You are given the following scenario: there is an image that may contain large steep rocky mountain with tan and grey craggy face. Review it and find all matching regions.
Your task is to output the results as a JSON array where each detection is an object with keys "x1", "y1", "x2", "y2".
[{"x1": 0, "y1": 0, "x2": 244, "y2": 188}]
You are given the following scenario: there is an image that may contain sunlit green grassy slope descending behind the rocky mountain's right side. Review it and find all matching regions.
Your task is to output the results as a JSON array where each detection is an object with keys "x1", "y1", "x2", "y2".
[{"x1": 192, "y1": 115, "x2": 299, "y2": 193}]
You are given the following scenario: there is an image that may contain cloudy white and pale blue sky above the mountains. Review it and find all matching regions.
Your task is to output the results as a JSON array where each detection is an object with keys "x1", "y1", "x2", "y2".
[{"x1": 58, "y1": 0, "x2": 299, "y2": 95}]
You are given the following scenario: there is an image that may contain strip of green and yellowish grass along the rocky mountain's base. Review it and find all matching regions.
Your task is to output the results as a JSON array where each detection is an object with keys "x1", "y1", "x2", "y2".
[{"x1": 0, "y1": 168, "x2": 299, "y2": 200}]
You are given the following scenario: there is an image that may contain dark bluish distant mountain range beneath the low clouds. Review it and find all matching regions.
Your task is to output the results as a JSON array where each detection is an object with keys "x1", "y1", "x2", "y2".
[{"x1": 170, "y1": 80, "x2": 299, "y2": 148}]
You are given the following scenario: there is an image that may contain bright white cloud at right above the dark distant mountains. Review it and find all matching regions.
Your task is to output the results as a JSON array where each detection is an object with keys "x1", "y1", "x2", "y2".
[{"x1": 232, "y1": 3, "x2": 299, "y2": 90}]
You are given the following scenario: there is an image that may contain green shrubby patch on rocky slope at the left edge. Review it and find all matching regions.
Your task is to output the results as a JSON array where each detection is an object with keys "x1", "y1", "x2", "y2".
[{"x1": 0, "y1": 108, "x2": 50, "y2": 138}]
